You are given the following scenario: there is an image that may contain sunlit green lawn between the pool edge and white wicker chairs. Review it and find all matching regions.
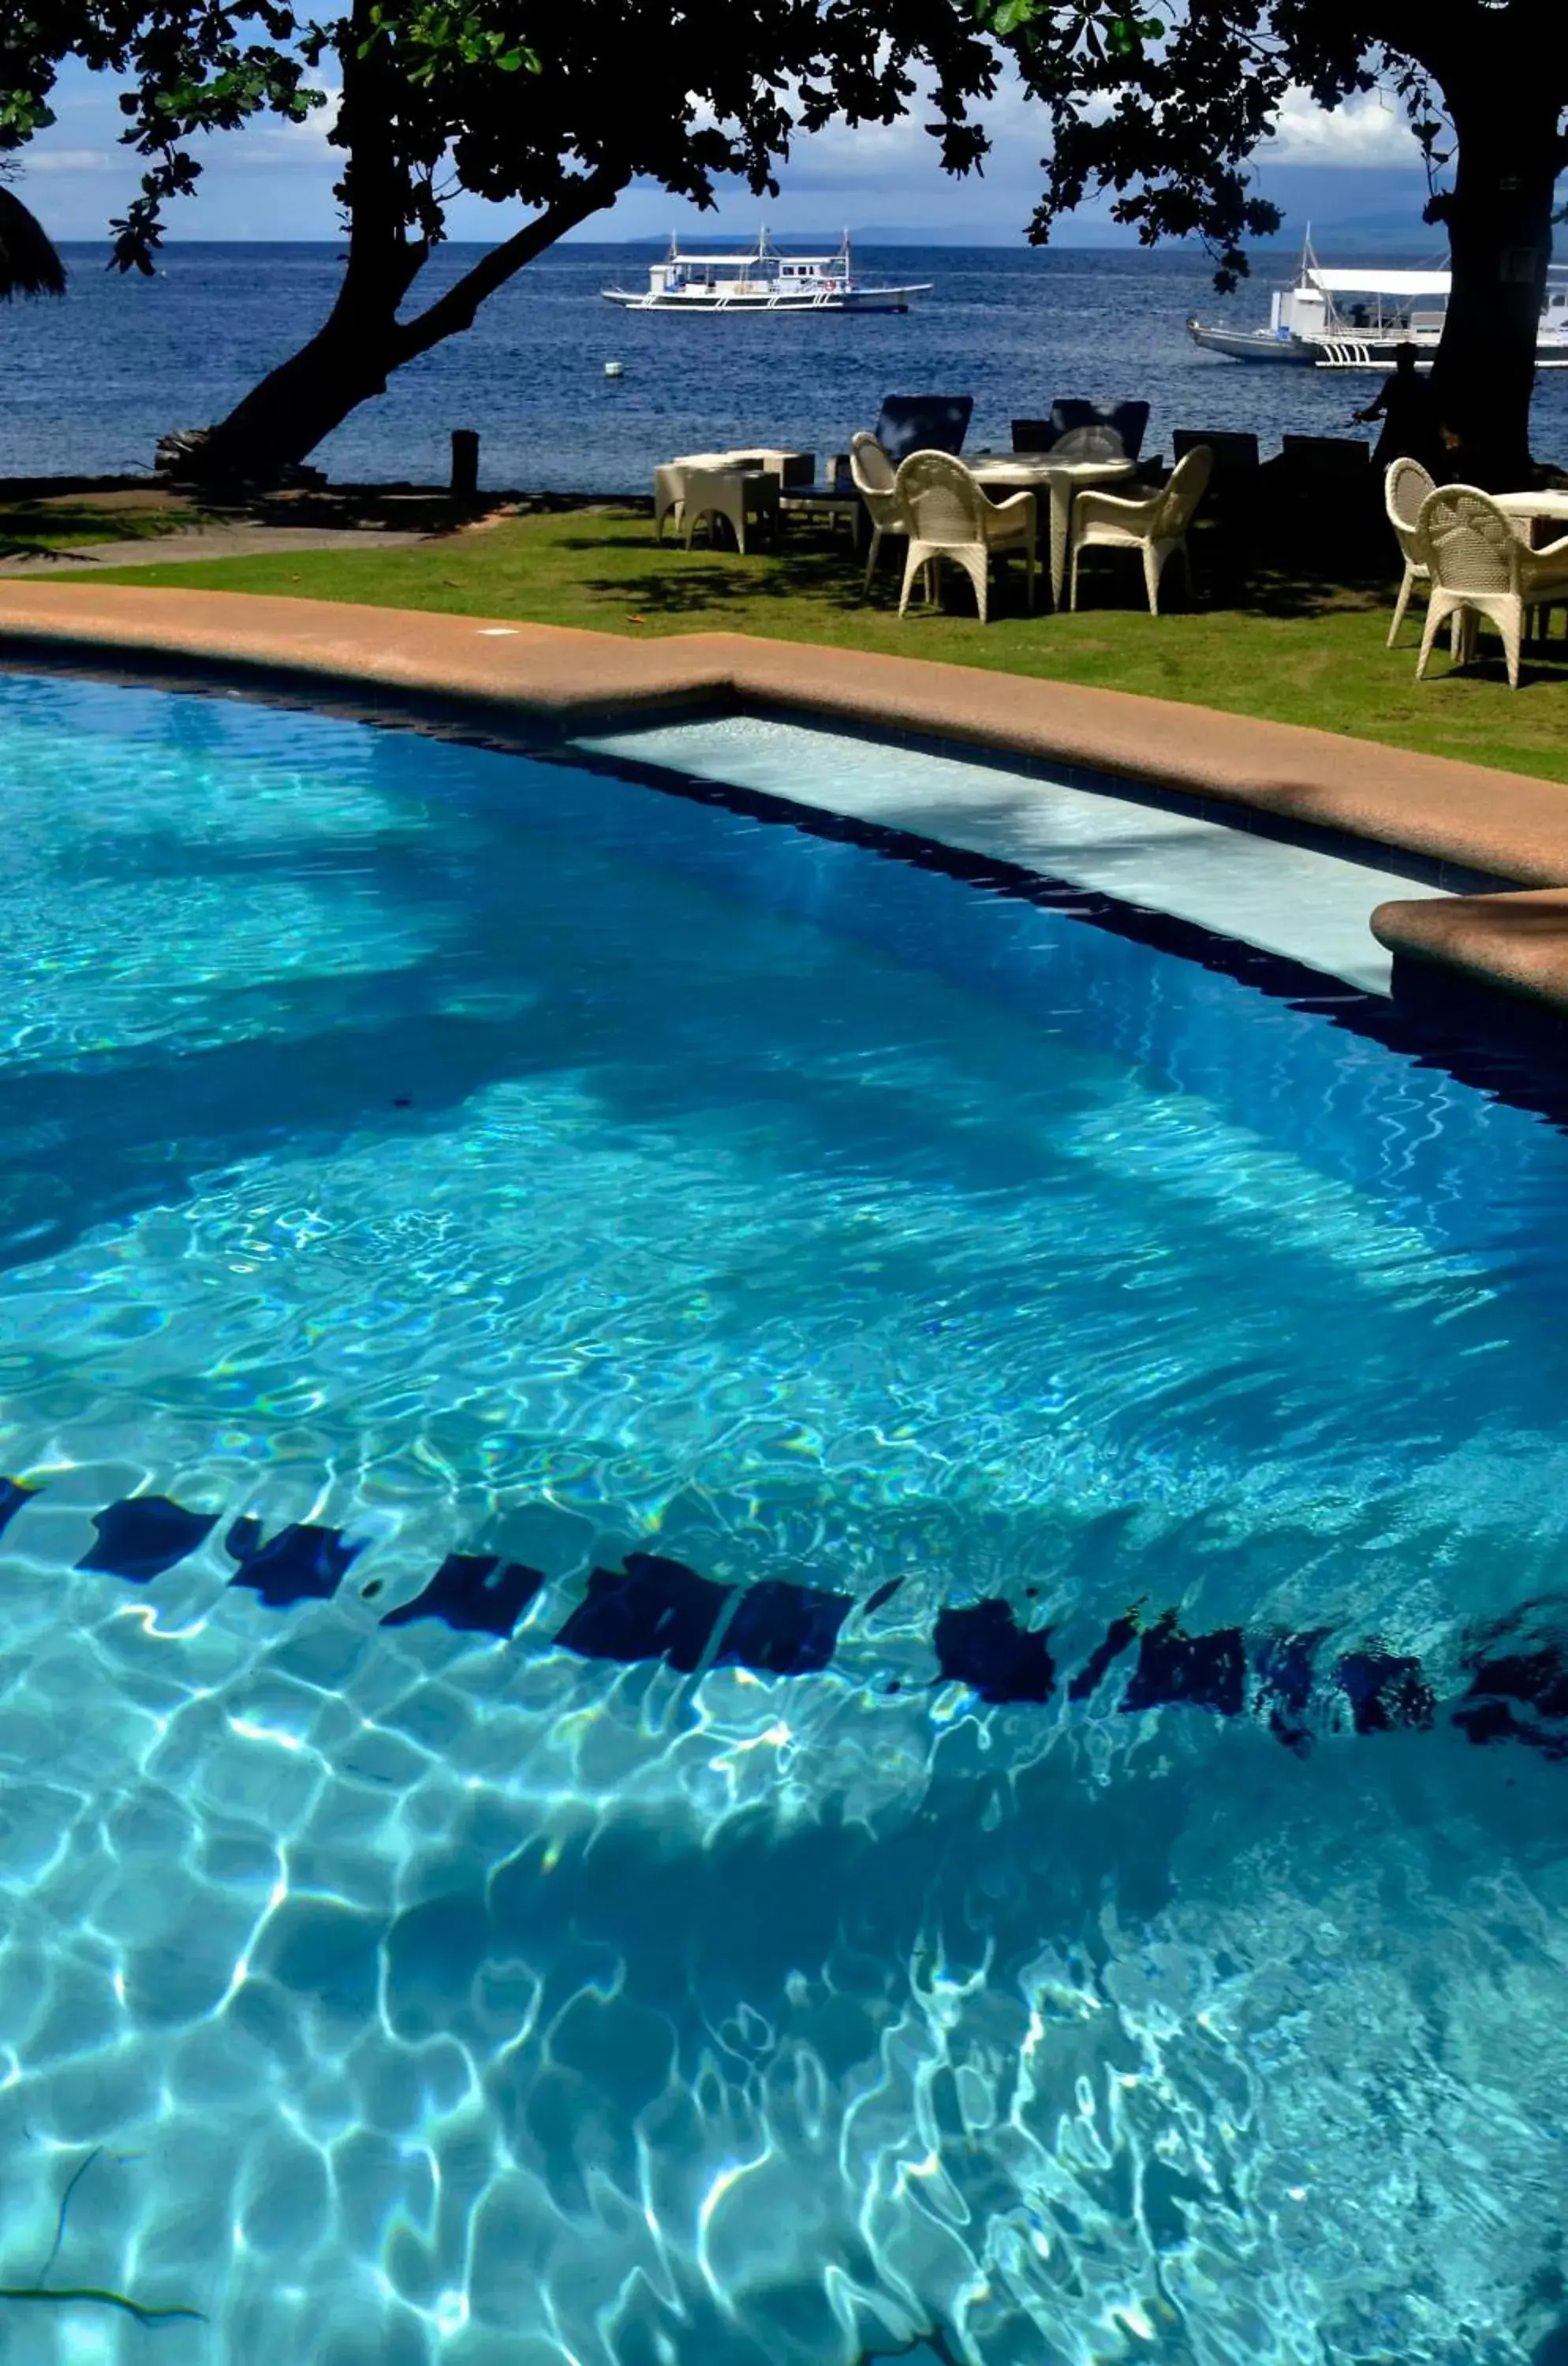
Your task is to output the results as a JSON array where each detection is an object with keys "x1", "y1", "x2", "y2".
[{"x1": 92, "y1": 506, "x2": 1568, "y2": 781}]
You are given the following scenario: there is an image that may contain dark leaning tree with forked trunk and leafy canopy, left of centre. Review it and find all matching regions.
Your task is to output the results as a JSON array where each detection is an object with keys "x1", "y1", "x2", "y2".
[{"x1": 162, "y1": 0, "x2": 998, "y2": 478}]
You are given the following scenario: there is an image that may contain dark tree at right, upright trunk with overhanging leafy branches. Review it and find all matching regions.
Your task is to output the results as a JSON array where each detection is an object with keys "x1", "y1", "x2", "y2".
[{"x1": 993, "y1": 0, "x2": 1568, "y2": 483}]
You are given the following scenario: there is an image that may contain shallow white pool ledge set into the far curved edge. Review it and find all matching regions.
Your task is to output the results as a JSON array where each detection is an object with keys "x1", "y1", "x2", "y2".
[{"x1": 577, "y1": 715, "x2": 1443, "y2": 994}]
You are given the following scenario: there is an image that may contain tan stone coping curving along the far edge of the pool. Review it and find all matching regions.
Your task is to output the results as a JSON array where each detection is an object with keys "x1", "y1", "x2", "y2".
[{"x1": 0, "y1": 582, "x2": 1568, "y2": 1008}]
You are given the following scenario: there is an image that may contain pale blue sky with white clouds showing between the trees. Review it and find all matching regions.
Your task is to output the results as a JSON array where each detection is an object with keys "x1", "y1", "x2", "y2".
[{"x1": 21, "y1": 53, "x2": 1431, "y2": 248}]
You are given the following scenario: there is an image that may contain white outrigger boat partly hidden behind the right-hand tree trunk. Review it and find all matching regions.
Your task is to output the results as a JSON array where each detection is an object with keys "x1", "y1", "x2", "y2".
[{"x1": 1187, "y1": 237, "x2": 1568, "y2": 369}]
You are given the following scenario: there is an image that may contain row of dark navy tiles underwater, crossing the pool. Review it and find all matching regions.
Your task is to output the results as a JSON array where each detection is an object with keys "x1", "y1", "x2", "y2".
[{"x1": 0, "y1": 1479, "x2": 1568, "y2": 1760}]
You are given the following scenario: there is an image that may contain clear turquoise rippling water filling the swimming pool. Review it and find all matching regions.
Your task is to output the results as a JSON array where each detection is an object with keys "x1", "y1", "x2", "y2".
[{"x1": 0, "y1": 677, "x2": 1568, "y2": 2366}]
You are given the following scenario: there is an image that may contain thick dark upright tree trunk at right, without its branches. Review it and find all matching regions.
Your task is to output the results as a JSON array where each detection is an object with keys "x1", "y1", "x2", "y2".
[{"x1": 1433, "y1": 77, "x2": 1563, "y2": 492}]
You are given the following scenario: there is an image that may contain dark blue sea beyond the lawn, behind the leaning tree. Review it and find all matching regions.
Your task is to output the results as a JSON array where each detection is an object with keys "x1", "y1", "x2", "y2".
[{"x1": 0, "y1": 244, "x2": 1568, "y2": 492}]
